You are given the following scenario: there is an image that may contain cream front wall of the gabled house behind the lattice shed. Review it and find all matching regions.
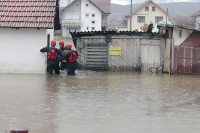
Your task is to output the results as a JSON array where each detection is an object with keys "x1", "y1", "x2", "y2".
[{"x1": 128, "y1": 3, "x2": 166, "y2": 30}]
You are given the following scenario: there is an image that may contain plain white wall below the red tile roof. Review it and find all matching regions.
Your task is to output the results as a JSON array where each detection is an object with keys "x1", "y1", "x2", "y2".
[{"x1": 0, "y1": 28, "x2": 47, "y2": 73}]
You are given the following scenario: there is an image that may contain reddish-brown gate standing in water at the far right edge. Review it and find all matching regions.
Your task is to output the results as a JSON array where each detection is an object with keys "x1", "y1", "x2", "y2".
[{"x1": 178, "y1": 46, "x2": 200, "y2": 74}]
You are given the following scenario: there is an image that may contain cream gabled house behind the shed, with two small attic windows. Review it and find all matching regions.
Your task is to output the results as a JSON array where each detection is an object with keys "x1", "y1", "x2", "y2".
[{"x1": 126, "y1": 0, "x2": 169, "y2": 31}]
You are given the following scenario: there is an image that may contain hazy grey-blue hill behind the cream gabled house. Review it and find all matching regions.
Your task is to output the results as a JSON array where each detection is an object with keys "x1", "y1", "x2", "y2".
[{"x1": 110, "y1": 2, "x2": 200, "y2": 20}]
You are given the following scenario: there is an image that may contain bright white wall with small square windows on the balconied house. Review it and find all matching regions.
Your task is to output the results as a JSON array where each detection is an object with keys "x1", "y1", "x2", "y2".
[{"x1": 81, "y1": 0, "x2": 102, "y2": 31}]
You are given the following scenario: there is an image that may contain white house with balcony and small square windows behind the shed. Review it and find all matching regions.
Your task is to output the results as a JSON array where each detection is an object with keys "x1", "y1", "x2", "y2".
[{"x1": 60, "y1": 0, "x2": 111, "y2": 36}]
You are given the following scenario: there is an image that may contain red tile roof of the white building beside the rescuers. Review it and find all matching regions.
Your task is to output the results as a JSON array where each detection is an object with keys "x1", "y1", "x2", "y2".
[{"x1": 0, "y1": 0, "x2": 56, "y2": 28}]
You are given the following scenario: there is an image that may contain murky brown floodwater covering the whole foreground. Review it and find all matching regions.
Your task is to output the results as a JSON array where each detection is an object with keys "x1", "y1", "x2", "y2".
[{"x1": 0, "y1": 71, "x2": 200, "y2": 133}]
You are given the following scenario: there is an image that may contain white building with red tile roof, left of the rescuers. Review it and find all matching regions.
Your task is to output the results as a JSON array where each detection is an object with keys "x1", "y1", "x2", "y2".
[{"x1": 0, "y1": 0, "x2": 56, "y2": 73}]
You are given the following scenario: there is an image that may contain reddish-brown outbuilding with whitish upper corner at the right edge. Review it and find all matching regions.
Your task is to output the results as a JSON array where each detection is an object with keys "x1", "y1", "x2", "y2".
[{"x1": 172, "y1": 26, "x2": 200, "y2": 74}]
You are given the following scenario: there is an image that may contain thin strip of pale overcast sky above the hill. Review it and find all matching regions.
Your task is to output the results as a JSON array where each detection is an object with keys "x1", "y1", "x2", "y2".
[{"x1": 111, "y1": 0, "x2": 200, "y2": 5}]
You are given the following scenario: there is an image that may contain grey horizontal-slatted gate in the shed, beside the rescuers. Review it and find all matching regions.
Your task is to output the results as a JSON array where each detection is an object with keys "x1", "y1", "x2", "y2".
[{"x1": 86, "y1": 43, "x2": 108, "y2": 70}]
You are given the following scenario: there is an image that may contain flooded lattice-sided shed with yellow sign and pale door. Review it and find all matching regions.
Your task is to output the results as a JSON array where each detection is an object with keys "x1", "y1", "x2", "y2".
[{"x1": 73, "y1": 32, "x2": 165, "y2": 71}]
